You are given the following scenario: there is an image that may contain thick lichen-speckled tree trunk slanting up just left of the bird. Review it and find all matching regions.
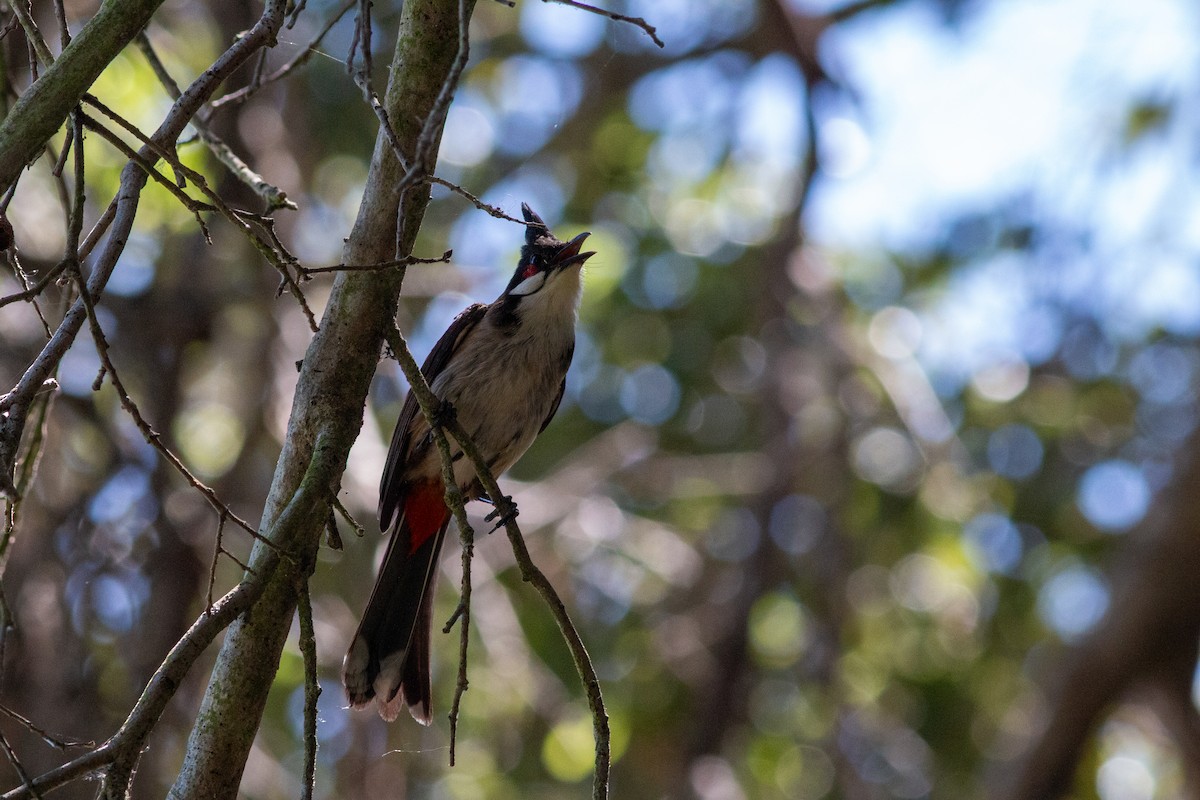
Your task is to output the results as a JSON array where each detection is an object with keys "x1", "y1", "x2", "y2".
[{"x1": 170, "y1": 0, "x2": 474, "y2": 799}]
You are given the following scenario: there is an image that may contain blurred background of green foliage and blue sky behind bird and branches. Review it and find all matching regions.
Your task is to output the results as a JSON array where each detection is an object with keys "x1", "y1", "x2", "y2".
[{"x1": 0, "y1": 0, "x2": 1200, "y2": 800}]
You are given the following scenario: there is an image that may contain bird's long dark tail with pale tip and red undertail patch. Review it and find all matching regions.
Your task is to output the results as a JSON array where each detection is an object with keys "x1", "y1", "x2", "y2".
[{"x1": 342, "y1": 480, "x2": 450, "y2": 724}]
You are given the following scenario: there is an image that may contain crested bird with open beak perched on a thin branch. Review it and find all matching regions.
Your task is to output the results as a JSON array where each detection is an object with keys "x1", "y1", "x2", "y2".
[{"x1": 342, "y1": 203, "x2": 595, "y2": 726}]
